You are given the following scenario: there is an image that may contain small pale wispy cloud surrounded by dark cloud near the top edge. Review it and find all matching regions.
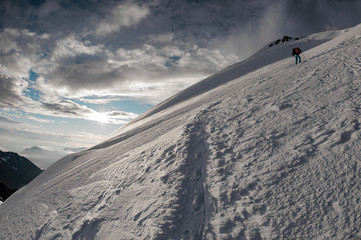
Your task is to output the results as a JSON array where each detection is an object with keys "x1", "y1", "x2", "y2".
[{"x1": 95, "y1": 2, "x2": 149, "y2": 36}]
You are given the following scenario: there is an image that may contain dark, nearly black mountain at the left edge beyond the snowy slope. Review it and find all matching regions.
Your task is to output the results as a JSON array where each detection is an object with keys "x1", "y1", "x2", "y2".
[{"x1": 0, "y1": 151, "x2": 42, "y2": 191}]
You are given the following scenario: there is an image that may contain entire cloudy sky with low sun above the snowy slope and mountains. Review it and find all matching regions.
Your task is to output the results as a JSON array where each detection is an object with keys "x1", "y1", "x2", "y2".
[{"x1": 0, "y1": 0, "x2": 361, "y2": 163}]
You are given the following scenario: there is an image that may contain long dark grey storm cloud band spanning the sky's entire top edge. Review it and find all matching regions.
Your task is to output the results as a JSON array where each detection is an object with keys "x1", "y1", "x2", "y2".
[{"x1": 0, "y1": 0, "x2": 361, "y2": 40}]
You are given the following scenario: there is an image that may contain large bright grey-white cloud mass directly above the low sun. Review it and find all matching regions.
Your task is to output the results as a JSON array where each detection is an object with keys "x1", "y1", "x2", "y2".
[{"x1": 31, "y1": 34, "x2": 238, "y2": 106}]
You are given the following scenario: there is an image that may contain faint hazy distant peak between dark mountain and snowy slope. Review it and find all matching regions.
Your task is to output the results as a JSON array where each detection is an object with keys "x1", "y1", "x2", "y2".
[{"x1": 21, "y1": 146, "x2": 66, "y2": 169}]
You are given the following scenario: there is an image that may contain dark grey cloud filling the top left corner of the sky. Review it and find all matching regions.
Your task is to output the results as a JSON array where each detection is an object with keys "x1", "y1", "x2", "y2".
[{"x1": 1, "y1": 0, "x2": 99, "y2": 33}]
